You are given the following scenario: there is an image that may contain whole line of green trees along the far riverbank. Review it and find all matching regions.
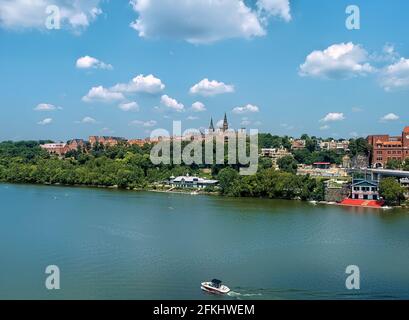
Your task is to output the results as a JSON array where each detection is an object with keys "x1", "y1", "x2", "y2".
[{"x1": 0, "y1": 134, "x2": 404, "y2": 205}]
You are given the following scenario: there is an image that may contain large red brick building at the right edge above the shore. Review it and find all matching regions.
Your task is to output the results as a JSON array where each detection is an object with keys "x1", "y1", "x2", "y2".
[{"x1": 367, "y1": 126, "x2": 409, "y2": 168}]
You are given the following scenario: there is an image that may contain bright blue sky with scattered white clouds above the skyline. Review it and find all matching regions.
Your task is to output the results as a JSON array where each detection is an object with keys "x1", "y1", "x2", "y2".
[{"x1": 0, "y1": 0, "x2": 409, "y2": 140}]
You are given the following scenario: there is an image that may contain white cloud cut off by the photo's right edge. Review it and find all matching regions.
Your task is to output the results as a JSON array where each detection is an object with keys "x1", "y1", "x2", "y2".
[{"x1": 381, "y1": 58, "x2": 409, "y2": 91}]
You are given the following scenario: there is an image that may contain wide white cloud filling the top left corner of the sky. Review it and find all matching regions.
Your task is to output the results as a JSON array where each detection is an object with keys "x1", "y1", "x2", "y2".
[{"x1": 0, "y1": 0, "x2": 102, "y2": 30}]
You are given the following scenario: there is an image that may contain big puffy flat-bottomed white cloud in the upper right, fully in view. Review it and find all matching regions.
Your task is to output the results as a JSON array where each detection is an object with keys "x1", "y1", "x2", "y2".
[{"x1": 299, "y1": 42, "x2": 374, "y2": 79}]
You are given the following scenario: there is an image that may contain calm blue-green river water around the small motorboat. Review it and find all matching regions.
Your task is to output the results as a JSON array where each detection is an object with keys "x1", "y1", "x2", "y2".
[{"x1": 0, "y1": 184, "x2": 409, "y2": 299}]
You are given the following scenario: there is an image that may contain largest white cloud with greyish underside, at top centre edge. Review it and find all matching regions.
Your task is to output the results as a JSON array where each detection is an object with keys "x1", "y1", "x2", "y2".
[{"x1": 131, "y1": 0, "x2": 266, "y2": 43}]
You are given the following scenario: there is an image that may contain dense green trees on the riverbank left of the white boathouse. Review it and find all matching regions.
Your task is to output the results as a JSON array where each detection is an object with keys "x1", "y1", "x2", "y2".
[{"x1": 0, "y1": 141, "x2": 197, "y2": 189}]
